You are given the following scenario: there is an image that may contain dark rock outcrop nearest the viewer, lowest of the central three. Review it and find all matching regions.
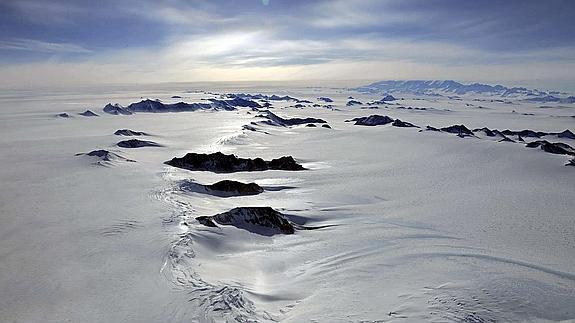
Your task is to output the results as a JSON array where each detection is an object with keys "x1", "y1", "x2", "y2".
[{"x1": 196, "y1": 207, "x2": 295, "y2": 235}]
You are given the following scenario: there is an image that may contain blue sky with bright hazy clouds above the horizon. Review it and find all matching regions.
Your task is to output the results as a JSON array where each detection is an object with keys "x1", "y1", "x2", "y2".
[{"x1": 0, "y1": 0, "x2": 575, "y2": 92}]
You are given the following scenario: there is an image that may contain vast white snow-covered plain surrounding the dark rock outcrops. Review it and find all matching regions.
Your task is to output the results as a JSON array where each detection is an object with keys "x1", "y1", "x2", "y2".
[{"x1": 0, "y1": 84, "x2": 575, "y2": 322}]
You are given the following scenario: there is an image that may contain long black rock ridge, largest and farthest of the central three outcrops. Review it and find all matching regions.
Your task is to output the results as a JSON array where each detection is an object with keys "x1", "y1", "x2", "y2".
[{"x1": 165, "y1": 152, "x2": 305, "y2": 173}]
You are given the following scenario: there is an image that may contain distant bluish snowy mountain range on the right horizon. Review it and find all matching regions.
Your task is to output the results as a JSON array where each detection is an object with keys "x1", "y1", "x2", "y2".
[{"x1": 355, "y1": 80, "x2": 575, "y2": 103}]
